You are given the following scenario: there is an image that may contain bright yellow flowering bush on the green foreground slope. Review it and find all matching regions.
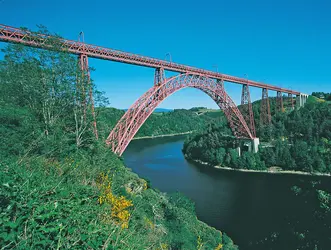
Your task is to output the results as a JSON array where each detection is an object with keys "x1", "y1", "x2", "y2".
[{"x1": 97, "y1": 173, "x2": 133, "y2": 228}]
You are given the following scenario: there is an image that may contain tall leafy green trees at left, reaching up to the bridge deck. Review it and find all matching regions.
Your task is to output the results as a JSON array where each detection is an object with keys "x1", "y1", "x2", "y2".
[{"x1": 0, "y1": 27, "x2": 99, "y2": 156}]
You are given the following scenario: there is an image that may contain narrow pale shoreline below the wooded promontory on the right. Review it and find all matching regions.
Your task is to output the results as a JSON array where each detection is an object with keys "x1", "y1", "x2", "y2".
[{"x1": 189, "y1": 158, "x2": 331, "y2": 176}]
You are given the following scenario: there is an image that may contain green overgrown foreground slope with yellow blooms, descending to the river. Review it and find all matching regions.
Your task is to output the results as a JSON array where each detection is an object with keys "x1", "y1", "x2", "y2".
[{"x1": 0, "y1": 149, "x2": 237, "y2": 250}]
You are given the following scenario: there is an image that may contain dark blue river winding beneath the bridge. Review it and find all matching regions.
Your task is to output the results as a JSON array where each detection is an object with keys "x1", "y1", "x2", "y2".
[{"x1": 124, "y1": 136, "x2": 330, "y2": 249}]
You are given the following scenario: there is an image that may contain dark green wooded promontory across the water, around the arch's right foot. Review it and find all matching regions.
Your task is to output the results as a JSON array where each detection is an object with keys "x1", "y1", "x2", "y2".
[{"x1": 183, "y1": 97, "x2": 331, "y2": 173}]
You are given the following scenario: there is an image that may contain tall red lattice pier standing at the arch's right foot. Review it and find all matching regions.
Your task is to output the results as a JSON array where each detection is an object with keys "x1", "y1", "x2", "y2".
[{"x1": 241, "y1": 84, "x2": 256, "y2": 137}]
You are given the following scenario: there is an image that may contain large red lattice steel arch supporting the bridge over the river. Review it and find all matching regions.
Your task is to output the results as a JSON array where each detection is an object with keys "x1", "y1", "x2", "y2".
[{"x1": 106, "y1": 73, "x2": 253, "y2": 155}]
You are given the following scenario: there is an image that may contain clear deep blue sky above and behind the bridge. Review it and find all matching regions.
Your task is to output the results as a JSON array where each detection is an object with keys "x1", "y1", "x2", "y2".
[{"x1": 0, "y1": 0, "x2": 331, "y2": 108}]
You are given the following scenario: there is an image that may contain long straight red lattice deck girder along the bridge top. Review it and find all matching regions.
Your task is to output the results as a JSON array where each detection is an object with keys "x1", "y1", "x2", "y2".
[{"x1": 0, "y1": 24, "x2": 300, "y2": 95}]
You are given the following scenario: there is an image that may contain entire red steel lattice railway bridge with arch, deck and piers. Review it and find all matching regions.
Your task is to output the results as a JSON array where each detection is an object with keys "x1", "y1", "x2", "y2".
[{"x1": 0, "y1": 24, "x2": 307, "y2": 155}]
